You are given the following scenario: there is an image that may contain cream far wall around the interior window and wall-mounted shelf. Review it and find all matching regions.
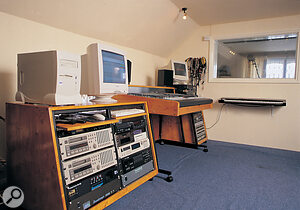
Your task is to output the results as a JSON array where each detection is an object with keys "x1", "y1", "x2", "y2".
[{"x1": 170, "y1": 15, "x2": 300, "y2": 151}]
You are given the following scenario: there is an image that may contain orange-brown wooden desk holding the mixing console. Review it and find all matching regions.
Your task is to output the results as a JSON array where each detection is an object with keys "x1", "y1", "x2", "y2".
[{"x1": 114, "y1": 86, "x2": 212, "y2": 147}]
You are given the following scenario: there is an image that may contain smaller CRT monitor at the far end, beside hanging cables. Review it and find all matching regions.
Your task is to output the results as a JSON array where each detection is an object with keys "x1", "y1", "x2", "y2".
[{"x1": 170, "y1": 60, "x2": 188, "y2": 84}]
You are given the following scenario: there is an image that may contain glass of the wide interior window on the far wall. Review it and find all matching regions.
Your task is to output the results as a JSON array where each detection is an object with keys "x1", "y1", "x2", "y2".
[{"x1": 214, "y1": 34, "x2": 298, "y2": 79}]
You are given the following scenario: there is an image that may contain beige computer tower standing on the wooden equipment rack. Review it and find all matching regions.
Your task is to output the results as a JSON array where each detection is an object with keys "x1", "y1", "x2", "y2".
[{"x1": 16, "y1": 50, "x2": 82, "y2": 105}]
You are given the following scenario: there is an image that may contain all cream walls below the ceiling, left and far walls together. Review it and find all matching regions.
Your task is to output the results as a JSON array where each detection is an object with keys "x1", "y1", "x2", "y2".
[{"x1": 0, "y1": 13, "x2": 300, "y2": 156}]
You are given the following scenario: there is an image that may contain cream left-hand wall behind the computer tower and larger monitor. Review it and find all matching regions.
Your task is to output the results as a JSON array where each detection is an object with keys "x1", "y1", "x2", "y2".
[{"x1": 0, "y1": 13, "x2": 168, "y2": 156}]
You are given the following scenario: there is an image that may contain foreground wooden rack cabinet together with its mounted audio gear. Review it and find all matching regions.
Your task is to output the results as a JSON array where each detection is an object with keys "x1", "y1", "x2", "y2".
[{"x1": 6, "y1": 102, "x2": 158, "y2": 210}]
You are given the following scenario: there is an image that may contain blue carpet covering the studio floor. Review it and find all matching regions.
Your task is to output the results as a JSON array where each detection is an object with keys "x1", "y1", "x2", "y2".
[{"x1": 106, "y1": 141, "x2": 300, "y2": 210}]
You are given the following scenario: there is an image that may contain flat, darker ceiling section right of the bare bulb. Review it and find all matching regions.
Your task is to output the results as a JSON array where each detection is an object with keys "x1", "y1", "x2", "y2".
[{"x1": 171, "y1": 0, "x2": 300, "y2": 26}]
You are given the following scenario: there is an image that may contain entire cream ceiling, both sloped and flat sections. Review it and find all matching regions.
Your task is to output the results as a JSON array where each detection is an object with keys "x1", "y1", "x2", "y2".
[{"x1": 0, "y1": 0, "x2": 300, "y2": 57}]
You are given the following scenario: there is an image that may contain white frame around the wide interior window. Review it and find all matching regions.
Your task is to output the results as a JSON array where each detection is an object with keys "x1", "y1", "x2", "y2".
[{"x1": 208, "y1": 30, "x2": 300, "y2": 84}]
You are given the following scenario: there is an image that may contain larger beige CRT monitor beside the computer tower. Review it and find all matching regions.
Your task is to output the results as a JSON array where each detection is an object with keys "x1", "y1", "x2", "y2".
[{"x1": 81, "y1": 43, "x2": 128, "y2": 102}]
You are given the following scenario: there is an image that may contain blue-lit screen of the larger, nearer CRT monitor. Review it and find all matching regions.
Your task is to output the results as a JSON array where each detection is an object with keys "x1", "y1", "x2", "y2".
[{"x1": 102, "y1": 50, "x2": 126, "y2": 84}]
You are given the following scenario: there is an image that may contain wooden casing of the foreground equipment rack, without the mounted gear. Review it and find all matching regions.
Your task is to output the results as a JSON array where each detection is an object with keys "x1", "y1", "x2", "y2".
[{"x1": 6, "y1": 102, "x2": 158, "y2": 210}]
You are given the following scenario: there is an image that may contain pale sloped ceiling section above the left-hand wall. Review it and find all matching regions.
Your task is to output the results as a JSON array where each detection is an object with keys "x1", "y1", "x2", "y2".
[{"x1": 0, "y1": 0, "x2": 198, "y2": 57}]
